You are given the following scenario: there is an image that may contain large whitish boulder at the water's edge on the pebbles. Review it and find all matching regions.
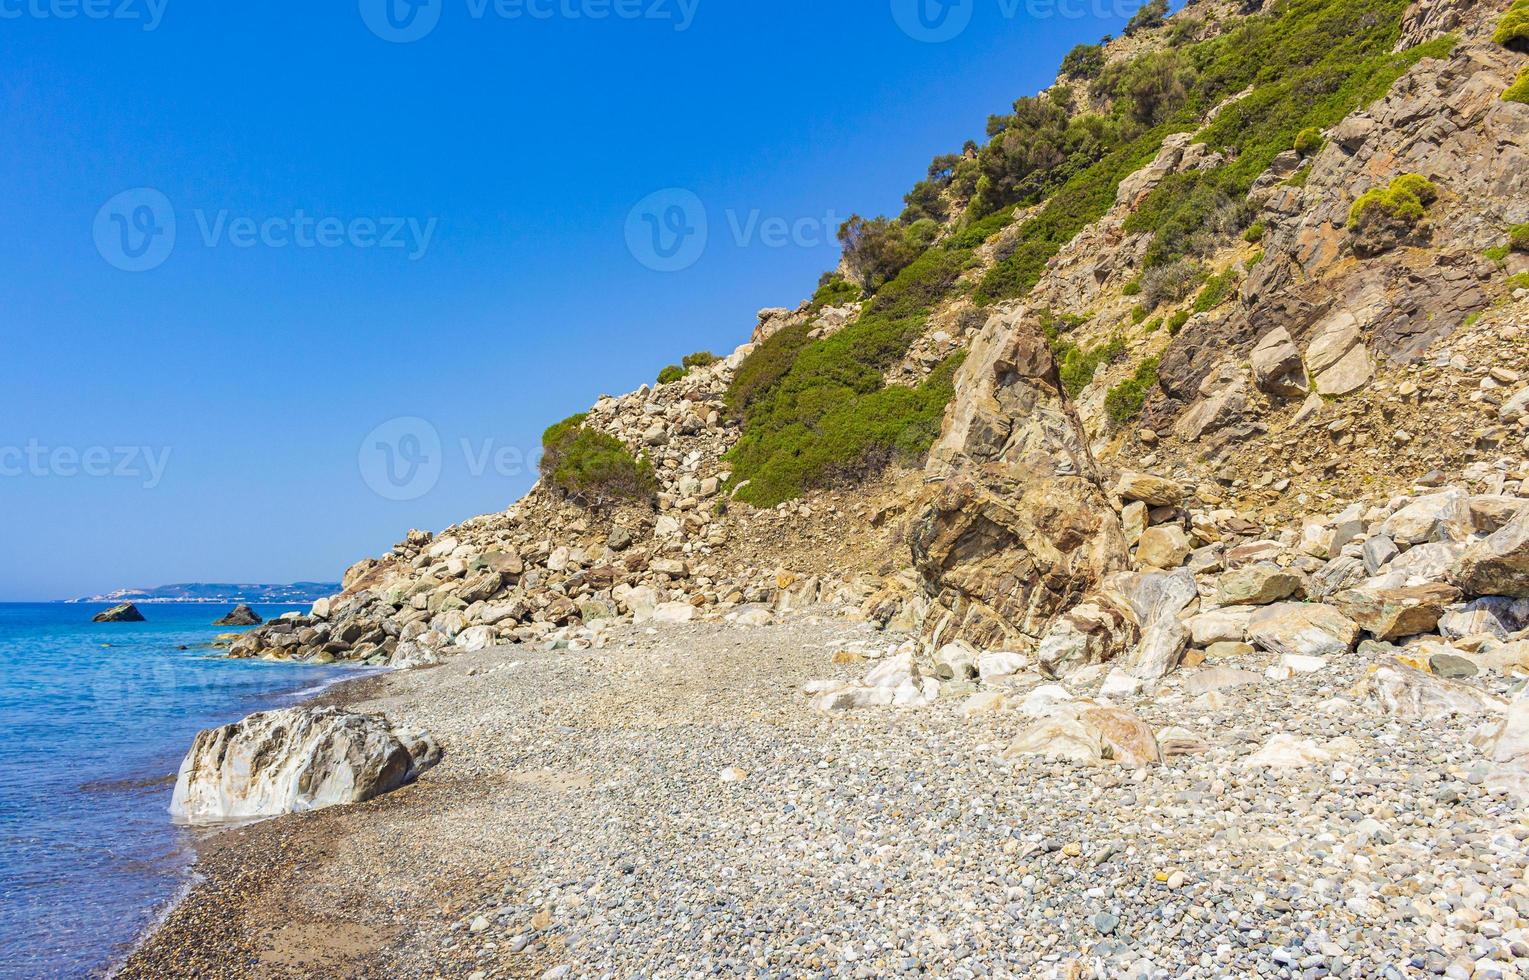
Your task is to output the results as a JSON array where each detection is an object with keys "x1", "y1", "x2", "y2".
[{"x1": 170, "y1": 708, "x2": 440, "y2": 826}]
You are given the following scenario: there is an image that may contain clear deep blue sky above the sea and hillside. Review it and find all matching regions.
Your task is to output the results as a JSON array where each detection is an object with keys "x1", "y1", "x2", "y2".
[{"x1": 0, "y1": 0, "x2": 1136, "y2": 601}]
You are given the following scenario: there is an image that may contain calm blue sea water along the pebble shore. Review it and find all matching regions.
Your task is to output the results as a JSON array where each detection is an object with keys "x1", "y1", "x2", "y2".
[{"x1": 0, "y1": 604, "x2": 353, "y2": 977}]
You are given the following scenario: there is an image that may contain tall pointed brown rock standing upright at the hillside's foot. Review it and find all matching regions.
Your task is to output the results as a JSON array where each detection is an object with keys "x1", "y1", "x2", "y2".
[{"x1": 910, "y1": 312, "x2": 1125, "y2": 650}]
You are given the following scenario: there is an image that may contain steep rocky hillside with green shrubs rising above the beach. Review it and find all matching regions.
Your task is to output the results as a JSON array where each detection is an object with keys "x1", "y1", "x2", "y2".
[{"x1": 226, "y1": 0, "x2": 1529, "y2": 665}]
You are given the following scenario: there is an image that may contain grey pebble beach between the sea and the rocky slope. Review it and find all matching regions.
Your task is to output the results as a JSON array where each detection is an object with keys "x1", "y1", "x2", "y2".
[{"x1": 121, "y1": 616, "x2": 1529, "y2": 977}]
